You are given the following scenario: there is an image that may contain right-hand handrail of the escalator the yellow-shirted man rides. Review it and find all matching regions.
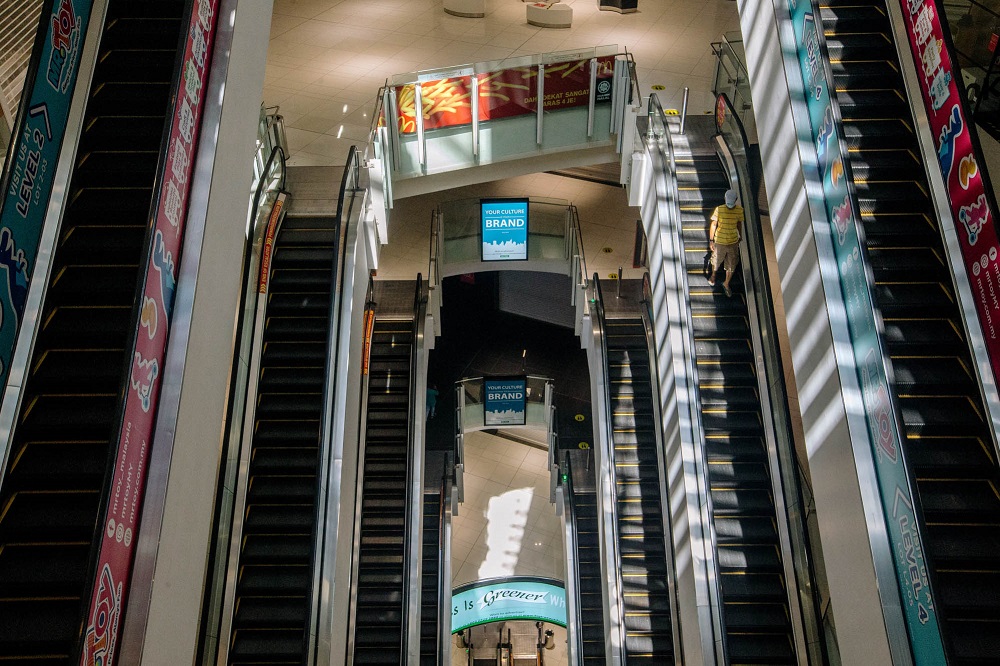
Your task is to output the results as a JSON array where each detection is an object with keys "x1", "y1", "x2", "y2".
[{"x1": 716, "y1": 88, "x2": 827, "y2": 660}]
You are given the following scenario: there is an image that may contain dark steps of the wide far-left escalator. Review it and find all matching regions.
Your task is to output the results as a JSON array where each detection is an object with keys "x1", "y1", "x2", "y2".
[{"x1": 0, "y1": 0, "x2": 186, "y2": 664}]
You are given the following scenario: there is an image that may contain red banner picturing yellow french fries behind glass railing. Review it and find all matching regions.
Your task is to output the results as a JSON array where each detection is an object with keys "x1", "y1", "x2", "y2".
[{"x1": 396, "y1": 56, "x2": 615, "y2": 134}]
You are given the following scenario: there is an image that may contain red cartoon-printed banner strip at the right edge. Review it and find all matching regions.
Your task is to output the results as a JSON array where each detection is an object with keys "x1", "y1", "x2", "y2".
[{"x1": 900, "y1": 0, "x2": 1000, "y2": 381}]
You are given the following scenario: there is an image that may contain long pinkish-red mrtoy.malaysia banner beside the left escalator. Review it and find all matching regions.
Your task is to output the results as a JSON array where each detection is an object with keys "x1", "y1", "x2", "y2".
[{"x1": 81, "y1": 0, "x2": 219, "y2": 666}]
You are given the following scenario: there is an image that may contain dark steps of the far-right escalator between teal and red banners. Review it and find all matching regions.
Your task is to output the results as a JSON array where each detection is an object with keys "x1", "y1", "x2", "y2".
[{"x1": 821, "y1": 0, "x2": 1000, "y2": 664}]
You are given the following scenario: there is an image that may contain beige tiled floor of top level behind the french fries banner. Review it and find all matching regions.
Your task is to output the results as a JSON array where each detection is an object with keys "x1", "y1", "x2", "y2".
[{"x1": 264, "y1": 0, "x2": 739, "y2": 165}]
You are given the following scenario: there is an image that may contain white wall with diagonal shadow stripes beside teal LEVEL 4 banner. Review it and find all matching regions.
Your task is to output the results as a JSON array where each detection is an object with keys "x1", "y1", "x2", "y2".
[{"x1": 738, "y1": 0, "x2": 895, "y2": 664}]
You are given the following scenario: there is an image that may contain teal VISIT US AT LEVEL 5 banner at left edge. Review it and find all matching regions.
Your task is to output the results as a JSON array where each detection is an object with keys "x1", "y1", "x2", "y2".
[{"x1": 0, "y1": 0, "x2": 93, "y2": 386}]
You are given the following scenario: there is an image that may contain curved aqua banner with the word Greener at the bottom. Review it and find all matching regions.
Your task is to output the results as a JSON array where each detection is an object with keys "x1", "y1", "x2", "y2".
[{"x1": 451, "y1": 576, "x2": 566, "y2": 634}]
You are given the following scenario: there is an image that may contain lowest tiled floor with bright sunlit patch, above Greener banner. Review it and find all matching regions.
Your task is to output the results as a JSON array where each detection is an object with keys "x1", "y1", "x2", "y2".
[{"x1": 451, "y1": 432, "x2": 566, "y2": 587}]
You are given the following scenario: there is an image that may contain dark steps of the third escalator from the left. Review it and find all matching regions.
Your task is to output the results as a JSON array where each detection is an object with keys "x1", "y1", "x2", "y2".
[{"x1": 352, "y1": 314, "x2": 416, "y2": 666}]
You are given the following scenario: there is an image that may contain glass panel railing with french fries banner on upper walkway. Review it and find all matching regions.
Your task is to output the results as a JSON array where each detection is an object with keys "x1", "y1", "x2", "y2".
[{"x1": 382, "y1": 46, "x2": 629, "y2": 178}]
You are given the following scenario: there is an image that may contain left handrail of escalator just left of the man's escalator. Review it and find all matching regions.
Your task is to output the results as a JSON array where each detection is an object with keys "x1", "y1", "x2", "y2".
[{"x1": 591, "y1": 273, "x2": 625, "y2": 660}]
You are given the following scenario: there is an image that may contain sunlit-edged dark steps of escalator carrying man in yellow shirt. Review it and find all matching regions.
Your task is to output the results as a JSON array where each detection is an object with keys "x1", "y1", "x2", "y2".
[{"x1": 676, "y1": 145, "x2": 796, "y2": 664}]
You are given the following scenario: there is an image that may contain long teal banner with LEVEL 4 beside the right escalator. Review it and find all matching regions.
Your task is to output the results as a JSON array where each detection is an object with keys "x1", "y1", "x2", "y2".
[{"x1": 788, "y1": 0, "x2": 945, "y2": 664}]
